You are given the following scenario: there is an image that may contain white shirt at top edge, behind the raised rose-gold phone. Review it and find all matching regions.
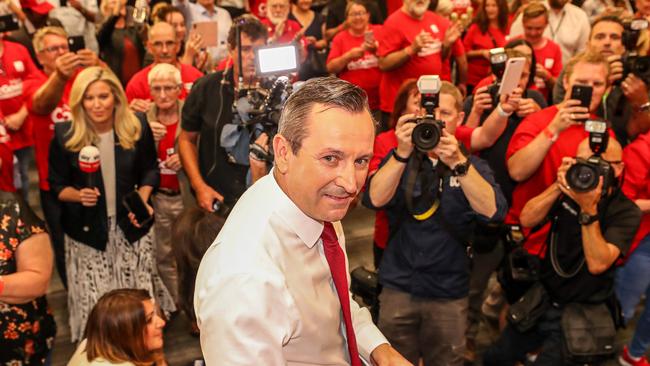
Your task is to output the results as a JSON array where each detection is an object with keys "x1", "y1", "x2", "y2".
[{"x1": 172, "y1": 0, "x2": 232, "y2": 63}]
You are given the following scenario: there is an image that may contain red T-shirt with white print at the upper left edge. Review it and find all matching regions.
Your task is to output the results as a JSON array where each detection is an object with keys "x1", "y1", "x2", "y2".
[{"x1": 0, "y1": 40, "x2": 39, "y2": 152}]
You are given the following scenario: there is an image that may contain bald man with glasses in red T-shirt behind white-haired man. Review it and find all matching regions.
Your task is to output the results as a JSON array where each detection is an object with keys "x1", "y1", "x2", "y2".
[{"x1": 126, "y1": 22, "x2": 203, "y2": 113}]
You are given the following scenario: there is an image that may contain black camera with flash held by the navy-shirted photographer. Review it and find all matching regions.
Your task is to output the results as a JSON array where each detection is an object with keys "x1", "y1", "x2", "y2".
[{"x1": 408, "y1": 75, "x2": 445, "y2": 152}]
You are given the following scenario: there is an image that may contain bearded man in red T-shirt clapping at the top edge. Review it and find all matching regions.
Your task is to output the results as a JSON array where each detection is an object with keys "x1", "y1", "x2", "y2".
[{"x1": 377, "y1": 0, "x2": 465, "y2": 130}]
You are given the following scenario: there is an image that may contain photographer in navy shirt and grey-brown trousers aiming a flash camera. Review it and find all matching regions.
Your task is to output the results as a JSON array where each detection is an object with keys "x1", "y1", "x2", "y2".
[{"x1": 363, "y1": 82, "x2": 507, "y2": 365}]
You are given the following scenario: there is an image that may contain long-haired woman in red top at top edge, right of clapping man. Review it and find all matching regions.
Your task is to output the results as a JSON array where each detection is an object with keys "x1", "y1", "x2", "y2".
[{"x1": 463, "y1": 0, "x2": 508, "y2": 93}]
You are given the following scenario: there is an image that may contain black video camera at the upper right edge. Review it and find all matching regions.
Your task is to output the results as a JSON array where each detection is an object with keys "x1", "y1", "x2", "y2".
[{"x1": 621, "y1": 19, "x2": 650, "y2": 83}]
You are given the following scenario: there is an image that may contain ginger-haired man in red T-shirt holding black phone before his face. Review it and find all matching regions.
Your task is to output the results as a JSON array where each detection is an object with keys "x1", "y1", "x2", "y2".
[{"x1": 506, "y1": 52, "x2": 609, "y2": 253}]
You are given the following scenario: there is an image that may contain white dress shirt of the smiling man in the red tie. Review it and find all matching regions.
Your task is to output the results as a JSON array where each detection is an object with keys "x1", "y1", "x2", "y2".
[{"x1": 194, "y1": 172, "x2": 388, "y2": 366}]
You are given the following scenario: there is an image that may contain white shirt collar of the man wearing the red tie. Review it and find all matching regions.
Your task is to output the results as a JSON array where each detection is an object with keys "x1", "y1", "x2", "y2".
[{"x1": 265, "y1": 169, "x2": 323, "y2": 248}]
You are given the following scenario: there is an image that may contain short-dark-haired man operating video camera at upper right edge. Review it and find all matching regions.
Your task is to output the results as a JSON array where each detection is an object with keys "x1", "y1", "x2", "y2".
[{"x1": 553, "y1": 15, "x2": 650, "y2": 146}]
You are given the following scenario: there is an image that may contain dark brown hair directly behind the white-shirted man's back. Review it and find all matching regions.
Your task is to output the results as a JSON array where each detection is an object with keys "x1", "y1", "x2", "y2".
[{"x1": 171, "y1": 207, "x2": 225, "y2": 335}]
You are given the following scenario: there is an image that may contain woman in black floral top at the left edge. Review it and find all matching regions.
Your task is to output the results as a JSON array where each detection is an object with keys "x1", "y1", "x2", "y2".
[{"x1": 0, "y1": 193, "x2": 56, "y2": 365}]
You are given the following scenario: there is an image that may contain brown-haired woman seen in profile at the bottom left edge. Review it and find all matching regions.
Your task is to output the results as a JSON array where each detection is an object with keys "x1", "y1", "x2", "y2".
[{"x1": 68, "y1": 289, "x2": 166, "y2": 366}]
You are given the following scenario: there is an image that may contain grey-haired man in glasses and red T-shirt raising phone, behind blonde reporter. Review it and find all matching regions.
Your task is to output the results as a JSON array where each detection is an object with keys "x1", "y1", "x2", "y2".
[{"x1": 23, "y1": 27, "x2": 100, "y2": 285}]
